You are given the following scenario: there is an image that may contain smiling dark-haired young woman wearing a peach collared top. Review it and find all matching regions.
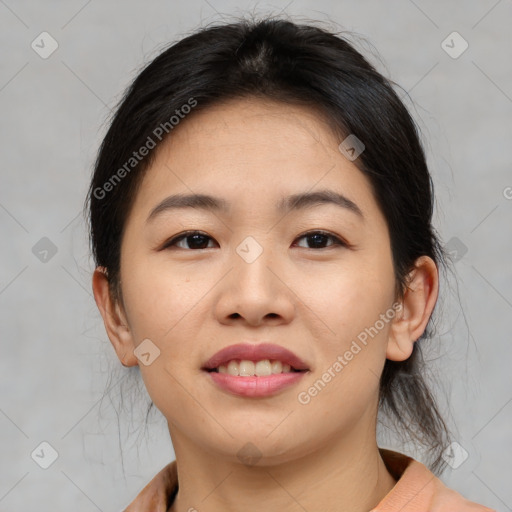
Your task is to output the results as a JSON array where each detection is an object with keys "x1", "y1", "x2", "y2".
[{"x1": 89, "y1": 19, "x2": 490, "y2": 512}]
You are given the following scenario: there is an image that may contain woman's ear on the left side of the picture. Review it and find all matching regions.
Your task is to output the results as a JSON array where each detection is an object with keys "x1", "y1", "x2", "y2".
[{"x1": 92, "y1": 267, "x2": 138, "y2": 366}]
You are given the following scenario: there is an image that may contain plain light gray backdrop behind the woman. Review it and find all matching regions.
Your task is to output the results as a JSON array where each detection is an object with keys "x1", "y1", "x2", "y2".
[{"x1": 0, "y1": 0, "x2": 512, "y2": 512}]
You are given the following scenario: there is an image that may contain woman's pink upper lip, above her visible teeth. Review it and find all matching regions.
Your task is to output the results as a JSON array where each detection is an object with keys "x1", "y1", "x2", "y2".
[{"x1": 203, "y1": 343, "x2": 309, "y2": 370}]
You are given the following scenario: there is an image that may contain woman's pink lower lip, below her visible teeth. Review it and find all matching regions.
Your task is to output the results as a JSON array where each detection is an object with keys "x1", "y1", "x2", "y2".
[{"x1": 207, "y1": 372, "x2": 307, "y2": 398}]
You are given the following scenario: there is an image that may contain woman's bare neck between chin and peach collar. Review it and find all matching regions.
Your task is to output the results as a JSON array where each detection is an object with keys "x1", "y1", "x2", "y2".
[{"x1": 170, "y1": 422, "x2": 396, "y2": 512}]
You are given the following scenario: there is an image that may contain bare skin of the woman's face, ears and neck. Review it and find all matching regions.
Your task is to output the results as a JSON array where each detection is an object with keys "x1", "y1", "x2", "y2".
[{"x1": 93, "y1": 98, "x2": 438, "y2": 512}]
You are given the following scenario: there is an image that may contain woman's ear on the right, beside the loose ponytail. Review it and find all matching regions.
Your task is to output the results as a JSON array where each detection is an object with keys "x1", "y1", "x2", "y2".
[{"x1": 386, "y1": 256, "x2": 439, "y2": 361}]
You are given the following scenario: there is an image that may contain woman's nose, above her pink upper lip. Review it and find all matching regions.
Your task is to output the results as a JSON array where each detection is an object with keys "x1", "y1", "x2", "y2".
[{"x1": 215, "y1": 244, "x2": 296, "y2": 327}]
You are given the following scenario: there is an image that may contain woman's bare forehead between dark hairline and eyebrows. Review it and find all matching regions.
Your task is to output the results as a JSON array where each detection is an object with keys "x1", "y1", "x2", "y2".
[{"x1": 130, "y1": 94, "x2": 376, "y2": 226}]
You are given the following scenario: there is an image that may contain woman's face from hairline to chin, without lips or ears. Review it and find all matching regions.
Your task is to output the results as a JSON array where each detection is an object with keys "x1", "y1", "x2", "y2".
[{"x1": 107, "y1": 99, "x2": 404, "y2": 464}]
